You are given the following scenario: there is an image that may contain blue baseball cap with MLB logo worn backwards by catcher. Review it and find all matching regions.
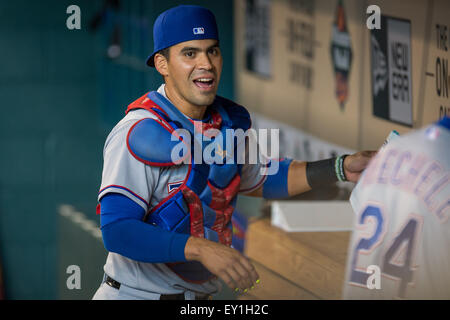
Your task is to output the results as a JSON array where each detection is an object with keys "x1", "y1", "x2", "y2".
[{"x1": 147, "y1": 5, "x2": 219, "y2": 67}]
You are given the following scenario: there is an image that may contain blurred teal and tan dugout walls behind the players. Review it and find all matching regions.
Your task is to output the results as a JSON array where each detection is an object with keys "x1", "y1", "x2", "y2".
[{"x1": 0, "y1": 0, "x2": 450, "y2": 299}]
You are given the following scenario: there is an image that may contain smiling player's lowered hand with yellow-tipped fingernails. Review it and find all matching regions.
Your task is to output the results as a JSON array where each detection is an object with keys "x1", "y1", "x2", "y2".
[{"x1": 185, "y1": 236, "x2": 259, "y2": 290}]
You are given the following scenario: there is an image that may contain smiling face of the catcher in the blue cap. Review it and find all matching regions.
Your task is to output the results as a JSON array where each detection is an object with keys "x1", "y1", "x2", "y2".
[{"x1": 155, "y1": 39, "x2": 223, "y2": 116}]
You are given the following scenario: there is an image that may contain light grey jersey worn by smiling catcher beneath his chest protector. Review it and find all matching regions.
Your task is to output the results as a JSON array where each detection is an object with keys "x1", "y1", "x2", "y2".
[{"x1": 93, "y1": 85, "x2": 266, "y2": 299}]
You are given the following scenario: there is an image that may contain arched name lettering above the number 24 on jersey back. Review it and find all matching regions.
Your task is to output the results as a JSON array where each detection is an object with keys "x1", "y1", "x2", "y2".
[{"x1": 361, "y1": 148, "x2": 450, "y2": 223}]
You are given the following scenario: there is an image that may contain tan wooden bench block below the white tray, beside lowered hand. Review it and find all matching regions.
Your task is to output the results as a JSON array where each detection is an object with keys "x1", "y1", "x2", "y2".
[{"x1": 240, "y1": 218, "x2": 350, "y2": 300}]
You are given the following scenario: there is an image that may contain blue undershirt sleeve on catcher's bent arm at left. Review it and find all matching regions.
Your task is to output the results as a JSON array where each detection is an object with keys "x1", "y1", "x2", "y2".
[{"x1": 100, "y1": 193, "x2": 189, "y2": 263}]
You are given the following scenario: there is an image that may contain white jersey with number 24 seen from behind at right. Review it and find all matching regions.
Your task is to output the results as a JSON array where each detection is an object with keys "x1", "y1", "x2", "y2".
[{"x1": 343, "y1": 125, "x2": 450, "y2": 299}]
